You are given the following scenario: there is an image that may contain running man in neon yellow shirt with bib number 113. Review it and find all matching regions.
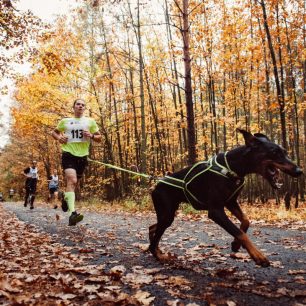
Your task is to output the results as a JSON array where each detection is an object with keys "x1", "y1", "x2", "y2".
[{"x1": 52, "y1": 99, "x2": 101, "y2": 225}]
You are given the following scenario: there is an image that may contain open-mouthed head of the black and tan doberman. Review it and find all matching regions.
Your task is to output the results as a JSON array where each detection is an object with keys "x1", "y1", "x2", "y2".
[{"x1": 237, "y1": 129, "x2": 303, "y2": 189}]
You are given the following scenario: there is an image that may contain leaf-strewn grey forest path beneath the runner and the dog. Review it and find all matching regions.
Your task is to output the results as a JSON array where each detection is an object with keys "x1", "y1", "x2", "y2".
[{"x1": 0, "y1": 203, "x2": 306, "y2": 306}]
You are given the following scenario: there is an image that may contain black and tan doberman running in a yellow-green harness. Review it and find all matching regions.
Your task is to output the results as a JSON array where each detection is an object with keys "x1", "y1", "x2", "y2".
[{"x1": 149, "y1": 129, "x2": 303, "y2": 267}]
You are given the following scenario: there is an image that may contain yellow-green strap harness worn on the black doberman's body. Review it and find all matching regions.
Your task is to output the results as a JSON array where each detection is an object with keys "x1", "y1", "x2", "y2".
[{"x1": 158, "y1": 152, "x2": 245, "y2": 205}]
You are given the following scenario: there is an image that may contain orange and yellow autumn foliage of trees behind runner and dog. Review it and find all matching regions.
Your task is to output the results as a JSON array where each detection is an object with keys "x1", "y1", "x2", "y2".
[{"x1": 1, "y1": 0, "x2": 306, "y2": 206}]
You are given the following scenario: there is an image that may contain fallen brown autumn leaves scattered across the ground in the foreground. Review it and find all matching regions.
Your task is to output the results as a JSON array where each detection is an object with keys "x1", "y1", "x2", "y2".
[{"x1": 0, "y1": 203, "x2": 306, "y2": 305}]
